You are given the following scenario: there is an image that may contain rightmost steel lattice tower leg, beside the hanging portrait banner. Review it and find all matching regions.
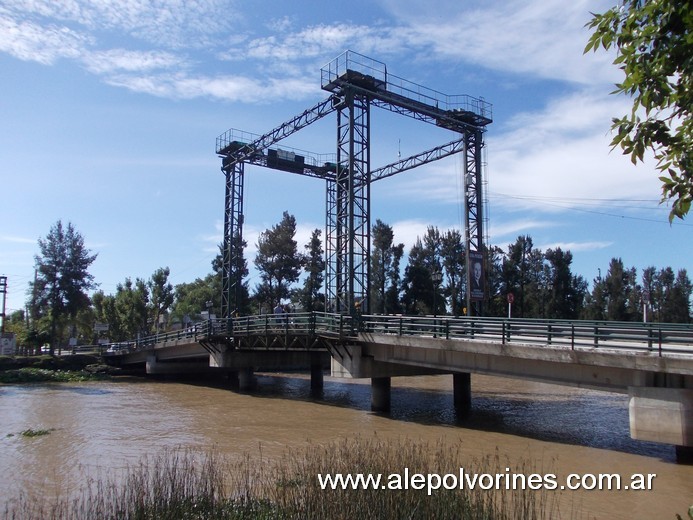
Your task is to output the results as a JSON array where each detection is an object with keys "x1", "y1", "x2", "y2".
[{"x1": 464, "y1": 131, "x2": 486, "y2": 316}]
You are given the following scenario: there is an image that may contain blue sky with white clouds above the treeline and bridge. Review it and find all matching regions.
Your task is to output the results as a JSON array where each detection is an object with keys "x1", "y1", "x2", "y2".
[{"x1": 0, "y1": 0, "x2": 693, "y2": 313}]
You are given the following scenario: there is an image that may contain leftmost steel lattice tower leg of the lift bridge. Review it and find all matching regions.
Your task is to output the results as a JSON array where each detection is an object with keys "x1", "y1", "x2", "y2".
[{"x1": 221, "y1": 162, "x2": 244, "y2": 318}]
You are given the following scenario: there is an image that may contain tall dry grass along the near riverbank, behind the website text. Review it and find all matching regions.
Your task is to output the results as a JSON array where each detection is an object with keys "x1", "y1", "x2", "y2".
[{"x1": 4, "y1": 438, "x2": 559, "y2": 520}]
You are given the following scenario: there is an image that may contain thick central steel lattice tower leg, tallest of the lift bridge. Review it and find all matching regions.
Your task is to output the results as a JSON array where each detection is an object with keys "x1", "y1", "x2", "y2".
[{"x1": 326, "y1": 93, "x2": 370, "y2": 314}]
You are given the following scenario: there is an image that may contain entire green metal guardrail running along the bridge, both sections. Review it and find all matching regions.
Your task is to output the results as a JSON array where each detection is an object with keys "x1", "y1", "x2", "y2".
[{"x1": 100, "y1": 312, "x2": 693, "y2": 356}]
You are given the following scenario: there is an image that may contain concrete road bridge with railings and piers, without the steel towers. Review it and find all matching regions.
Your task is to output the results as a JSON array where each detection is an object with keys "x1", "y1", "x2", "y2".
[{"x1": 108, "y1": 313, "x2": 693, "y2": 460}]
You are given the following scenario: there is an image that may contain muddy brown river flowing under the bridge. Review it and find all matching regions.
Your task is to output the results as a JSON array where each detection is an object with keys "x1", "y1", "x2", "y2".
[{"x1": 0, "y1": 374, "x2": 693, "y2": 520}]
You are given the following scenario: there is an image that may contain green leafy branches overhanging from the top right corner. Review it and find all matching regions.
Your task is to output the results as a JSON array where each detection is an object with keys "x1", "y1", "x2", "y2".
[{"x1": 585, "y1": 0, "x2": 693, "y2": 221}]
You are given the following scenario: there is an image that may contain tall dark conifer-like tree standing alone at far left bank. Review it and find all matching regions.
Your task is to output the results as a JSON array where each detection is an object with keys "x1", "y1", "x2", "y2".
[{"x1": 30, "y1": 220, "x2": 97, "y2": 355}]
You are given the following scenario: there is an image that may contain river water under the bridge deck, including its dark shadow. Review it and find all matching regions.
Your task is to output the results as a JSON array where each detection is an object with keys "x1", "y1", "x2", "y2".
[{"x1": 194, "y1": 374, "x2": 676, "y2": 462}]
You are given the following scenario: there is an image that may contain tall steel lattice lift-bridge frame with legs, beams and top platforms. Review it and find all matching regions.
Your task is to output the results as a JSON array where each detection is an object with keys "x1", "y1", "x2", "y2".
[{"x1": 216, "y1": 51, "x2": 492, "y2": 318}]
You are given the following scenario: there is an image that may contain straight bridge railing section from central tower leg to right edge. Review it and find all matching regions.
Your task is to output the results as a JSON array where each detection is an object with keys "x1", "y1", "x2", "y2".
[{"x1": 358, "y1": 315, "x2": 693, "y2": 355}]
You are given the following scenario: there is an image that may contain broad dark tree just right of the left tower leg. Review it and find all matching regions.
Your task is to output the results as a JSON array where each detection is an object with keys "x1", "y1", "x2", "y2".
[{"x1": 255, "y1": 211, "x2": 304, "y2": 309}]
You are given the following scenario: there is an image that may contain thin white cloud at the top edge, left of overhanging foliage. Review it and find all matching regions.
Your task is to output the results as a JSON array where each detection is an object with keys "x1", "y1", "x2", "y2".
[{"x1": 386, "y1": 0, "x2": 617, "y2": 84}]
